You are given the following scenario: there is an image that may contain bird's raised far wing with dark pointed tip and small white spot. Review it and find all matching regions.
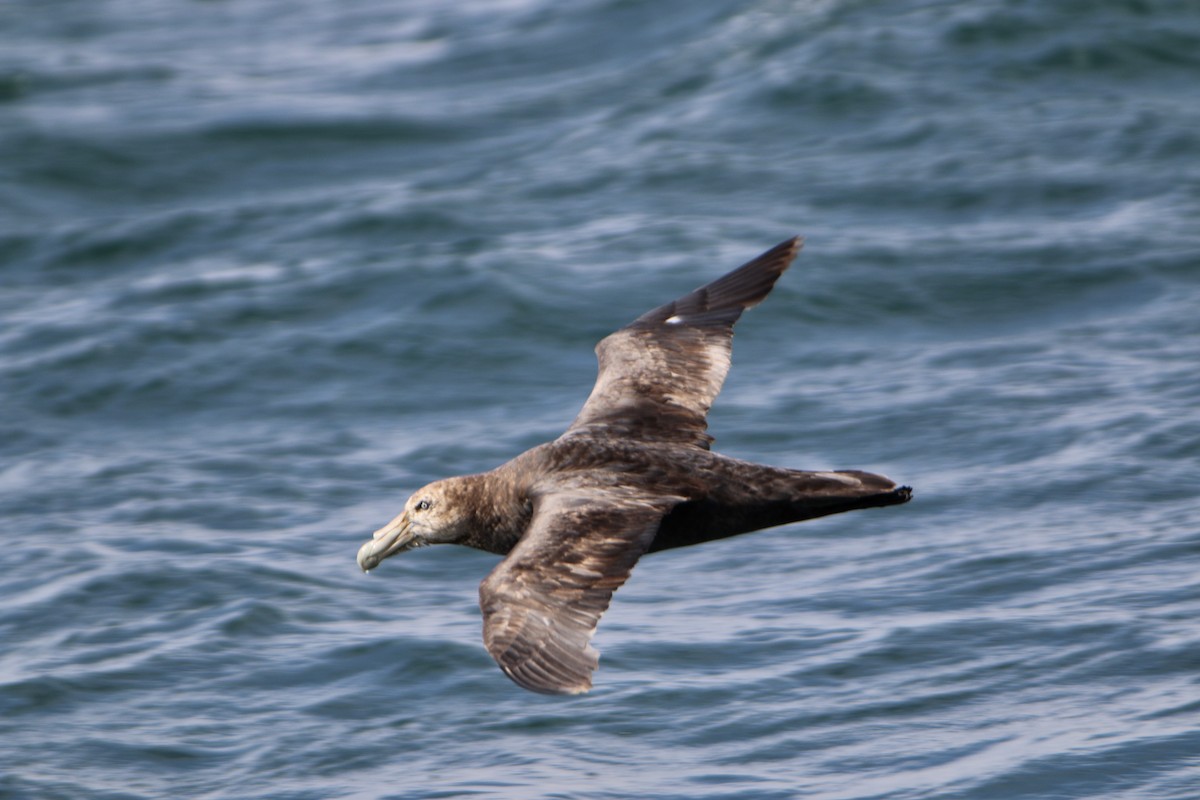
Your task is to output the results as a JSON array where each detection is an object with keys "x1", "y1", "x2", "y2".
[{"x1": 566, "y1": 237, "x2": 803, "y2": 450}]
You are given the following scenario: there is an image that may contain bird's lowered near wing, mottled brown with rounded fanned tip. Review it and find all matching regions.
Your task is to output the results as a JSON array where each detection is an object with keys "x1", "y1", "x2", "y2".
[{"x1": 479, "y1": 486, "x2": 680, "y2": 694}]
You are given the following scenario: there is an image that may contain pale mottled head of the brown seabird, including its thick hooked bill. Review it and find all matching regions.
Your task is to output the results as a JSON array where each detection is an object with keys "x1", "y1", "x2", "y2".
[{"x1": 359, "y1": 477, "x2": 470, "y2": 571}]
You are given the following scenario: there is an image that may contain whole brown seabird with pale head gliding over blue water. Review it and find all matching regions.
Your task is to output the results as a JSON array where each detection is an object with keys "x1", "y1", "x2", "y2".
[{"x1": 359, "y1": 237, "x2": 912, "y2": 694}]
